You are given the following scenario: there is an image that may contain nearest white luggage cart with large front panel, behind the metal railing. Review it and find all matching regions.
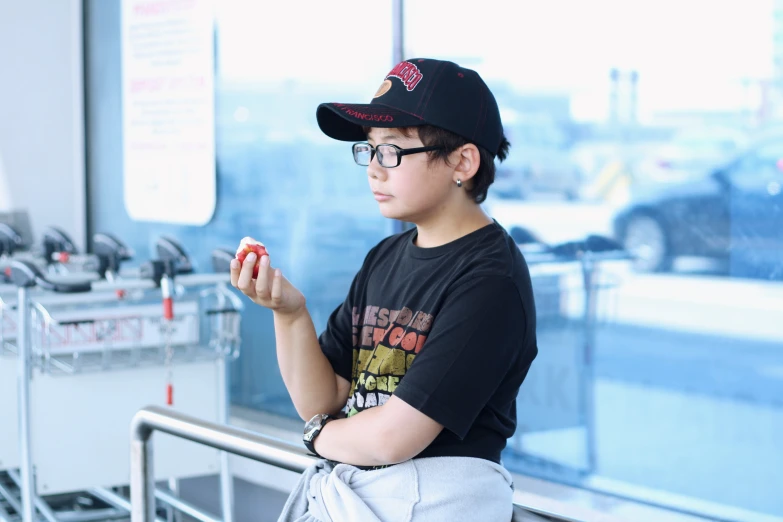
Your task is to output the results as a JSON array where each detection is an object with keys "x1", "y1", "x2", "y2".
[{"x1": 0, "y1": 241, "x2": 242, "y2": 522}]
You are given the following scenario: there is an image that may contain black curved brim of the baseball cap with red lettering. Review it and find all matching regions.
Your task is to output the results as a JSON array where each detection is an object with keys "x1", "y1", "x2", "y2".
[{"x1": 315, "y1": 103, "x2": 425, "y2": 141}]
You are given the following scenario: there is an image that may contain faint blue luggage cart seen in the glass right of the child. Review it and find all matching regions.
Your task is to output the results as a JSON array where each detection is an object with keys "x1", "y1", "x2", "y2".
[{"x1": 504, "y1": 236, "x2": 630, "y2": 482}]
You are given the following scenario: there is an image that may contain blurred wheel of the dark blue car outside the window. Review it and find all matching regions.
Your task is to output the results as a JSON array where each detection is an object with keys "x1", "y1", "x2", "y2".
[{"x1": 623, "y1": 215, "x2": 672, "y2": 272}]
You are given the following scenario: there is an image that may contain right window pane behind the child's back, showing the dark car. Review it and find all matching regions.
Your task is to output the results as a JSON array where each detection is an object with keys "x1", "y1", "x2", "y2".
[{"x1": 404, "y1": 0, "x2": 783, "y2": 520}]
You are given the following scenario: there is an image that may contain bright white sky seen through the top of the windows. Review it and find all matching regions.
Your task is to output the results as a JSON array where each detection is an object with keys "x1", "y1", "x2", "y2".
[{"x1": 217, "y1": 0, "x2": 773, "y2": 120}]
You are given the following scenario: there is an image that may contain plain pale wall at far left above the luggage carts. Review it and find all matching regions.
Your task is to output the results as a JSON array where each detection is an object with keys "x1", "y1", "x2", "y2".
[{"x1": 0, "y1": 0, "x2": 86, "y2": 249}]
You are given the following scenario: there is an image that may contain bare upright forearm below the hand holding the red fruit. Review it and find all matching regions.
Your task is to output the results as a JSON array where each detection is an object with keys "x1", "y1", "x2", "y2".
[{"x1": 274, "y1": 308, "x2": 344, "y2": 420}]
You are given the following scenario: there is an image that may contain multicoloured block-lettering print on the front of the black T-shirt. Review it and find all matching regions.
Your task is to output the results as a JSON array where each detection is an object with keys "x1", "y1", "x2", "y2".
[{"x1": 345, "y1": 306, "x2": 435, "y2": 417}]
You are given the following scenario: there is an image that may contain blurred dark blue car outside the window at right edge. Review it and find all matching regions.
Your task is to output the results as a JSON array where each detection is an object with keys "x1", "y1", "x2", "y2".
[{"x1": 613, "y1": 140, "x2": 783, "y2": 272}]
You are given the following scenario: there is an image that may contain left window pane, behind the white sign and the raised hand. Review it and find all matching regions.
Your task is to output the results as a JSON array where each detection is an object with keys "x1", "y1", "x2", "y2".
[{"x1": 86, "y1": 0, "x2": 393, "y2": 418}]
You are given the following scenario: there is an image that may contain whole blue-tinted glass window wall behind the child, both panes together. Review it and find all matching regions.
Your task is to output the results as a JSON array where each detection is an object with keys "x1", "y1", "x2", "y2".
[{"x1": 85, "y1": 0, "x2": 783, "y2": 520}]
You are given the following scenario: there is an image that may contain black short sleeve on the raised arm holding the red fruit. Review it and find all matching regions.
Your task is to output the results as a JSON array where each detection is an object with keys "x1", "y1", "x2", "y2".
[{"x1": 318, "y1": 246, "x2": 377, "y2": 382}]
